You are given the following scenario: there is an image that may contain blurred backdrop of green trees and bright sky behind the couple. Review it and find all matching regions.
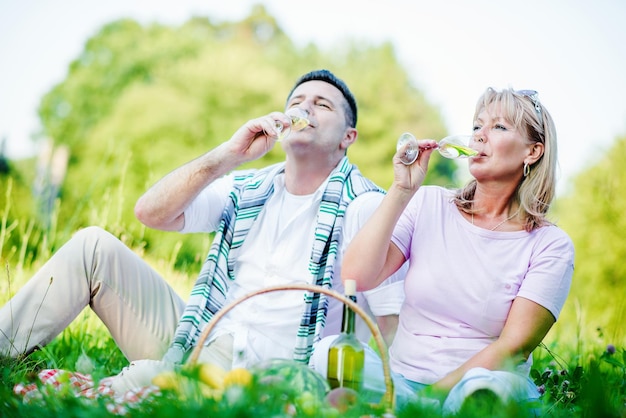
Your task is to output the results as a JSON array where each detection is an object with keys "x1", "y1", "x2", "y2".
[{"x1": 0, "y1": 0, "x2": 626, "y2": 345}]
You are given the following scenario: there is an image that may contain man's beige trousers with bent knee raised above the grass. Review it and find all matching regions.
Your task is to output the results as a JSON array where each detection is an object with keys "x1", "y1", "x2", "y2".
[{"x1": 0, "y1": 227, "x2": 185, "y2": 361}]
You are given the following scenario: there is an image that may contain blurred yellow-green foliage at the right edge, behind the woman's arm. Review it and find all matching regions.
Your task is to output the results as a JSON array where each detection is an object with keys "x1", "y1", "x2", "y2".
[{"x1": 556, "y1": 137, "x2": 626, "y2": 344}]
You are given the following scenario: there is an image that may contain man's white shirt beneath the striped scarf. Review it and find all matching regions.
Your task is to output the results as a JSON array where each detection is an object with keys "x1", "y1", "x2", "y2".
[{"x1": 181, "y1": 170, "x2": 405, "y2": 367}]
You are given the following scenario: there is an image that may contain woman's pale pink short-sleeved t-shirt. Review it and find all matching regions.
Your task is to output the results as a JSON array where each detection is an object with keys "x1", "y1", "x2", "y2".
[{"x1": 390, "y1": 186, "x2": 574, "y2": 384}]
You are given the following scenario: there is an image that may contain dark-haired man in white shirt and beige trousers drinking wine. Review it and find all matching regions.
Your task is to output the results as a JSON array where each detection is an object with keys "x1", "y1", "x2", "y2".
[{"x1": 0, "y1": 70, "x2": 403, "y2": 384}]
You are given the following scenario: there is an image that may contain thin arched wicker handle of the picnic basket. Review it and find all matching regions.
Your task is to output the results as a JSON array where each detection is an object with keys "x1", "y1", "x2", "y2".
[{"x1": 188, "y1": 283, "x2": 395, "y2": 411}]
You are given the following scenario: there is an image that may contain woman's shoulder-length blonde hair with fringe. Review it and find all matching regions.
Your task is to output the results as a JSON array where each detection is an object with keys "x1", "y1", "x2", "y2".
[{"x1": 454, "y1": 88, "x2": 557, "y2": 232}]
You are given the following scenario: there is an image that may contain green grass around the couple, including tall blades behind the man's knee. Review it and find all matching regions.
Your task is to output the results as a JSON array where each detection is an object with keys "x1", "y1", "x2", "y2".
[{"x1": 0, "y1": 192, "x2": 626, "y2": 418}]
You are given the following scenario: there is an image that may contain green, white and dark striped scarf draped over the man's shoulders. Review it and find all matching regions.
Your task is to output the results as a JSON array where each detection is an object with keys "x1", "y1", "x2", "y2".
[{"x1": 164, "y1": 157, "x2": 383, "y2": 363}]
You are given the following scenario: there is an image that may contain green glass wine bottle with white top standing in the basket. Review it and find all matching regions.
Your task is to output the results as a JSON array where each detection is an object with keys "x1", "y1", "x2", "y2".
[{"x1": 327, "y1": 280, "x2": 365, "y2": 391}]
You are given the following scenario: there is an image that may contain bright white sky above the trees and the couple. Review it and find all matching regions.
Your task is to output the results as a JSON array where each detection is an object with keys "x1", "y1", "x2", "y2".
[{"x1": 0, "y1": 0, "x2": 626, "y2": 190}]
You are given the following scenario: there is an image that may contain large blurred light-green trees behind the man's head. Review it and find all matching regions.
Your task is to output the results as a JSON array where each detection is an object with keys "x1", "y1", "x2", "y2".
[{"x1": 0, "y1": 6, "x2": 457, "y2": 268}]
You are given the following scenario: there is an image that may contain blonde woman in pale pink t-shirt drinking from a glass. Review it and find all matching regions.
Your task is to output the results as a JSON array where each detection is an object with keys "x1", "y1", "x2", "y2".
[{"x1": 343, "y1": 88, "x2": 574, "y2": 412}]
